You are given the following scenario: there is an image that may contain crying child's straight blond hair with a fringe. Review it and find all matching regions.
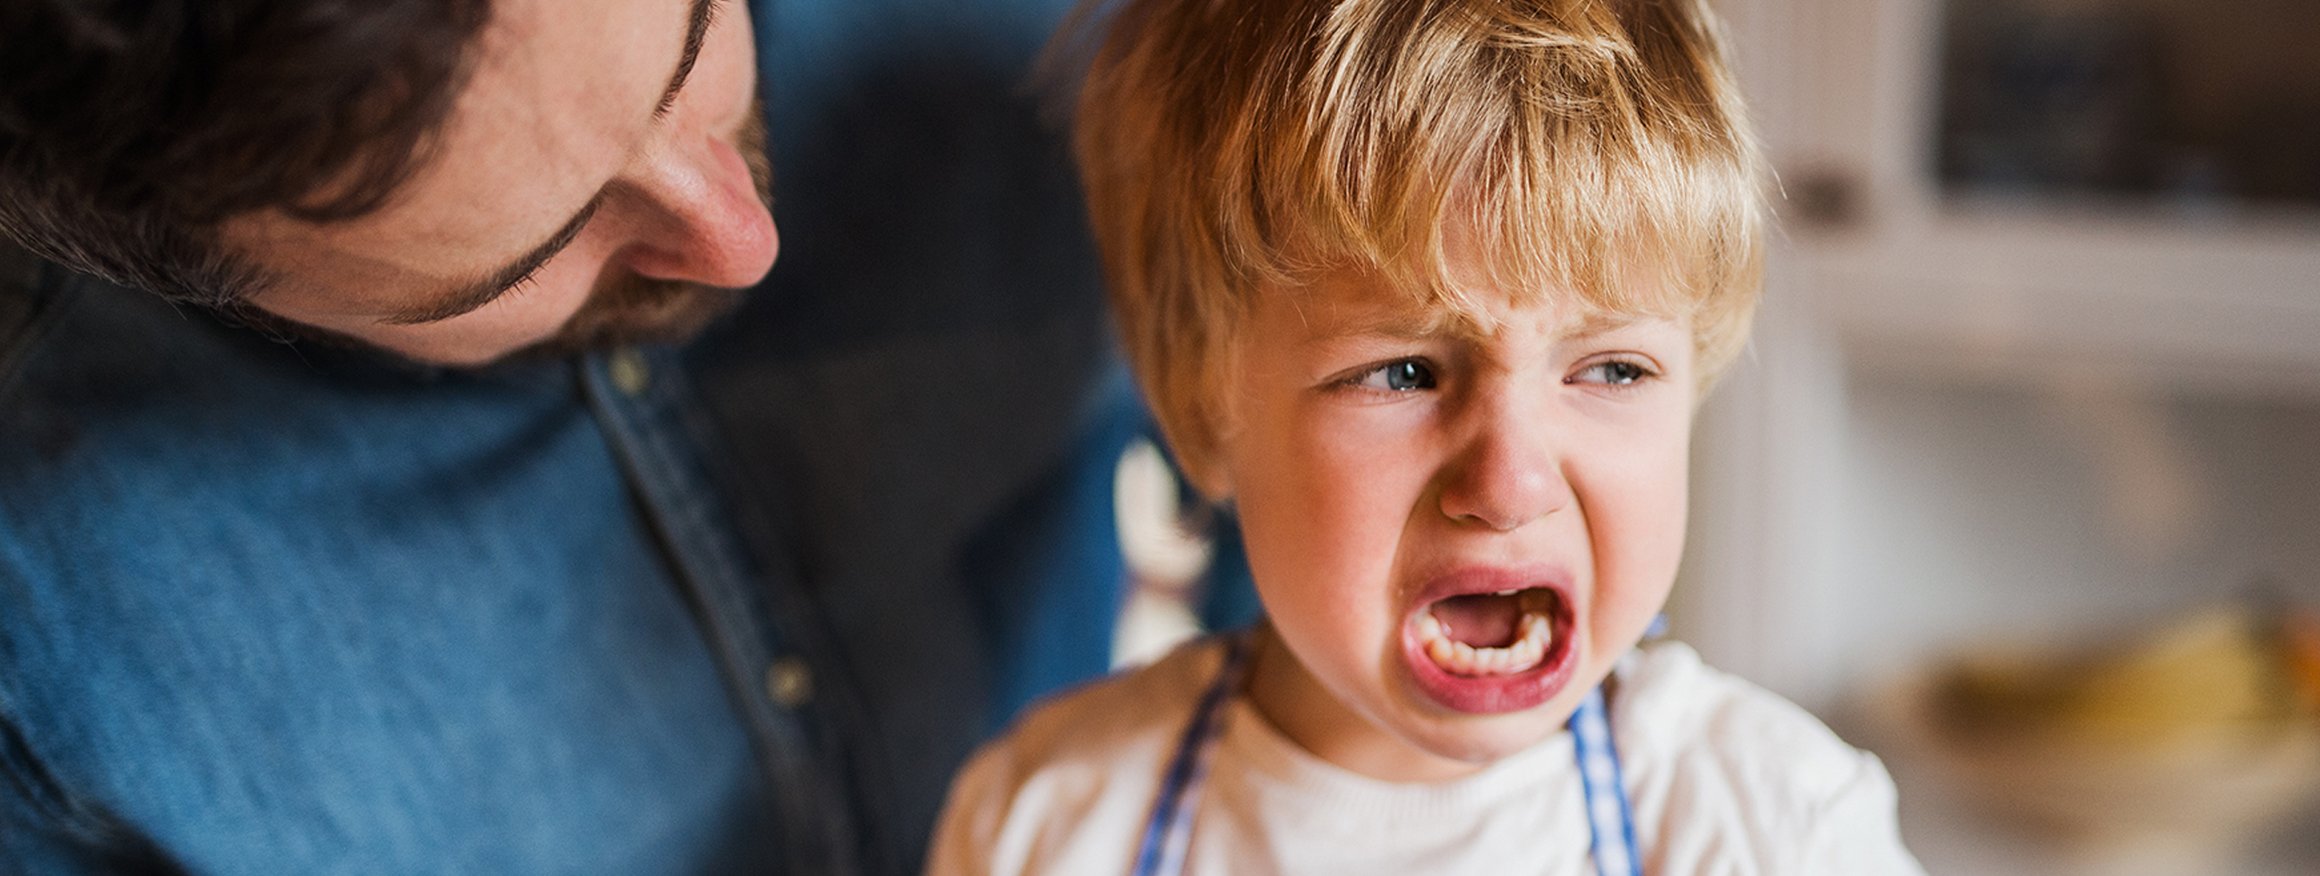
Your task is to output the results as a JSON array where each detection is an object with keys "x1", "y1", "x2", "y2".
[{"x1": 1058, "y1": 0, "x2": 1763, "y2": 484}]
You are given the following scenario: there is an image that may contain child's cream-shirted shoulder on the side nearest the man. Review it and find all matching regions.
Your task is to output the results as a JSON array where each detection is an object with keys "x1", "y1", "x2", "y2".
[{"x1": 928, "y1": 637, "x2": 1225, "y2": 874}]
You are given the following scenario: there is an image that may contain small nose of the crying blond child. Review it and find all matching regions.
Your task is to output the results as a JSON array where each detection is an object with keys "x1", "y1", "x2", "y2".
[{"x1": 1441, "y1": 392, "x2": 1571, "y2": 533}]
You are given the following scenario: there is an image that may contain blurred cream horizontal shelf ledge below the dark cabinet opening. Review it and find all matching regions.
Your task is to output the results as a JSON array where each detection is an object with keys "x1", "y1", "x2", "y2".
[{"x1": 1800, "y1": 204, "x2": 2320, "y2": 399}]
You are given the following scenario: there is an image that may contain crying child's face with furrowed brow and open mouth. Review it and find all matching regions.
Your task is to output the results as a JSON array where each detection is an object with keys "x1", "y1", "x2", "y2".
[{"x1": 1223, "y1": 263, "x2": 1696, "y2": 779}]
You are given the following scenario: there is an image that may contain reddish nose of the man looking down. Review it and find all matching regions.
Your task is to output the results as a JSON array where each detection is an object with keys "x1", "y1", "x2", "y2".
[{"x1": 622, "y1": 125, "x2": 782, "y2": 290}]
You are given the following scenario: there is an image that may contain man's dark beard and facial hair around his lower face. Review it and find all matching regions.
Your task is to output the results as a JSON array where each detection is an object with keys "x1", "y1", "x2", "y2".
[{"x1": 510, "y1": 102, "x2": 773, "y2": 359}]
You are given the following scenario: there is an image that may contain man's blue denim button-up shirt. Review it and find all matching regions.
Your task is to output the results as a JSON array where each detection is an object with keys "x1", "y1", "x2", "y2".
[{"x1": 0, "y1": 2, "x2": 1137, "y2": 874}]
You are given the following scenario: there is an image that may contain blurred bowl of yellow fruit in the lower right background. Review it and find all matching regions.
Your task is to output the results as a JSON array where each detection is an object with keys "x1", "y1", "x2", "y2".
[{"x1": 1877, "y1": 605, "x2": 2320, "y2": 860}]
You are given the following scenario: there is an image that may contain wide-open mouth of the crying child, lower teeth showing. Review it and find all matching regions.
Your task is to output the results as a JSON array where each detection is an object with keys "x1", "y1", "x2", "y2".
[{"x1": 1401, "y1": 570, "x2": 1578, "y2": 714}]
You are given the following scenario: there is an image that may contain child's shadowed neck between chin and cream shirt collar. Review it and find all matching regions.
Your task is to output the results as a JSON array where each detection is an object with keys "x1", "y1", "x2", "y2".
[{"x1": 1248, "y1": 623, "x2": 1482, "y2": 781}]
